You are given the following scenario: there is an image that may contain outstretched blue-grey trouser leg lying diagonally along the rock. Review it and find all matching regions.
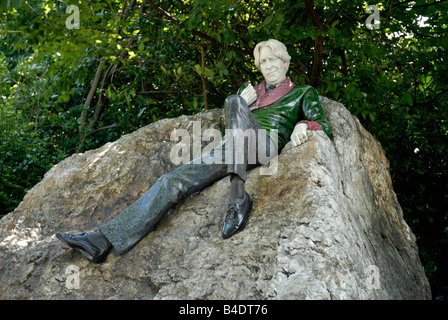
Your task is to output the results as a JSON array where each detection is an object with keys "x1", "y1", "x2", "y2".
[{"x1": 100, "y1": 151, "x2": 227, "y2": 254}]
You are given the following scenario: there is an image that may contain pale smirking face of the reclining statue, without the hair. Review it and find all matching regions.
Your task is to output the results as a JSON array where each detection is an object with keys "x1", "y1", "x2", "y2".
[{"x1": 260, "y1": 47, "x2": 288, "y2": 85}]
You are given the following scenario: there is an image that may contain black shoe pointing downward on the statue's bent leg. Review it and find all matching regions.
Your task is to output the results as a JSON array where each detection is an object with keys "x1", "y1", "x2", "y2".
[{"x1": 222, "y1": 192, "x2": 252, "y2": 239}]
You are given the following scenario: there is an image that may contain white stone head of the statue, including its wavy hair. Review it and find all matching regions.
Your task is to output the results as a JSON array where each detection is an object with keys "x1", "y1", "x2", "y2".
[{"x1": 254, "y1": 39, "x2": 291, "y2": 85}]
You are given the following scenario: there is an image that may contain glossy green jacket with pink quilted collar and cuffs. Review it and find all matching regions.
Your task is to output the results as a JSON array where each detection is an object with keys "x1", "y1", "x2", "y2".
[{"x1": 238, "y1": 78, "x2": 331, "y2": 150}]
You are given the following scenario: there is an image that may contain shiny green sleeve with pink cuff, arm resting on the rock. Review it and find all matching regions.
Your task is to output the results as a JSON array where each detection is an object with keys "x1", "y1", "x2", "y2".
[{"x1": 296, "y1": 87, "x2": 331, "y2": 136}]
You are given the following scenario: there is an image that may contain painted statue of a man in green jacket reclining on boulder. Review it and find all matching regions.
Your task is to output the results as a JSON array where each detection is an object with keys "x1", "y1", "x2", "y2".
[{"x1": 56, "y1": 39, "x2": 331, "y2": 263}]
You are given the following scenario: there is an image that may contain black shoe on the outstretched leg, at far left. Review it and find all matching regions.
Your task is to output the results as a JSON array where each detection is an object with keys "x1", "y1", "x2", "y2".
[{"x1": 56, "y1": 231, "x2": 112, "y2": 263}]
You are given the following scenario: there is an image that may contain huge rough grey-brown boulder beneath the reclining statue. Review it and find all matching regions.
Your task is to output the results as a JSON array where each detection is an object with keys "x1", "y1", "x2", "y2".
[{"x1": 0, "y1": 98, "x2": 431, "y2": 299}]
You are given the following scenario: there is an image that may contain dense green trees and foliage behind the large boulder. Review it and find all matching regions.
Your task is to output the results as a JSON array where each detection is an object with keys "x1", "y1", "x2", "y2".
[{"x1": 0, "y1": 0, "x2": 448, "y2": 298}]
